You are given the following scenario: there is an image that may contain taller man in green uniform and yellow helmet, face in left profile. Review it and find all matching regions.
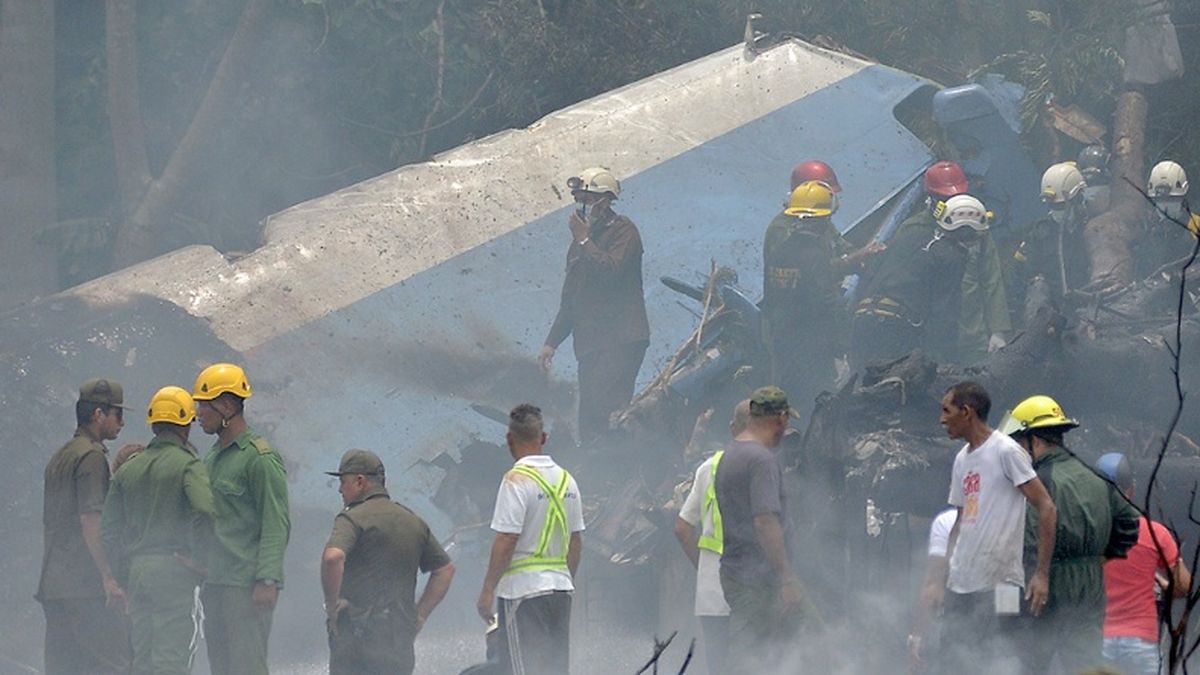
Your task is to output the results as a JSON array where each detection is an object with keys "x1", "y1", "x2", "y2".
[{"x1": 192, "y1": 363, "x2": 292, "y2": 675}]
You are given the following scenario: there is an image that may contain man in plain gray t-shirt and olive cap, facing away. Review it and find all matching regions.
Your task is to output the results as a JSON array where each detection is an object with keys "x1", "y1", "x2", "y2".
[{"x1": 716, "y1": 387, "x2": 820, "y2": 671}]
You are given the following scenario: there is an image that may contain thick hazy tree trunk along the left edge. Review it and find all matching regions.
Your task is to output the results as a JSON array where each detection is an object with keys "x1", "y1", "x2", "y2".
[{"x1": 0, "y1": 0, "x2": 58, "y2": 311}]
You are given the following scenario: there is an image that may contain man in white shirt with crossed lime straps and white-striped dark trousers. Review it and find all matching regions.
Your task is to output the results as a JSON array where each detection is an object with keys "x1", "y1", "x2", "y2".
[{"x1": 475, "y1": 404, "x2": 583, "y2": 675}]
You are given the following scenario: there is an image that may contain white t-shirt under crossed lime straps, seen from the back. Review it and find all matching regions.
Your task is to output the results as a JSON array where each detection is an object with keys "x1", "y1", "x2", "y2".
[{"x1": 492, "y1": 455, "x2": 583, "y2": 599}]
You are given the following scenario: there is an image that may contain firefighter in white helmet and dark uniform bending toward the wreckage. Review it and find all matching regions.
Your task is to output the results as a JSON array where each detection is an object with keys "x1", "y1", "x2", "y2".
[{"x1": 851, "y1": 189, "x2": 989, "y2": 368}]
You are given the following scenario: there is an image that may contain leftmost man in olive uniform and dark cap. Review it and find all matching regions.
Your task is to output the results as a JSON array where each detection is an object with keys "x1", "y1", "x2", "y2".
[{"x1": 35, "y1": 380, "x2": 130, "y2": 675}]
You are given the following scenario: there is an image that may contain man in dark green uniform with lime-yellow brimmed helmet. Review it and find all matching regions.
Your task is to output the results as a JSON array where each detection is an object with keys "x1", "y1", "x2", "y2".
[{"x1": 1000, "y1": 396, "x2": 1140, "y2": 674}]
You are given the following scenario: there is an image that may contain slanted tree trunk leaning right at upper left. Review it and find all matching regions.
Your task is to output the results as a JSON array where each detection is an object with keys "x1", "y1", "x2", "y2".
[{"x1": 114, "y1": 0, "x2": 271, "y2": 268}]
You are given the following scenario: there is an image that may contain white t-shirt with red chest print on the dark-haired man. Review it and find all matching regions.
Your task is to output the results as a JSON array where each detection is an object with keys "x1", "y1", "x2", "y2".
[{"x1": 946, "y1": 431, "x2": 1037, "y2": 593}]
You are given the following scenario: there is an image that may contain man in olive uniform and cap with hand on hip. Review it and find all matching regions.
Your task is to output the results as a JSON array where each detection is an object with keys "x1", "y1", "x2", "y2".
[{"x1": 320, "y1": 450, "x2": 455, "y2": 675}]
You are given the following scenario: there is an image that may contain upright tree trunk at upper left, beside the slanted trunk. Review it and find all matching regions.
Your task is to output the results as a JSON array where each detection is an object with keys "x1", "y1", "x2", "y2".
[{"x1": 104, "y1": 0, "x2": 150, "y2": 217}]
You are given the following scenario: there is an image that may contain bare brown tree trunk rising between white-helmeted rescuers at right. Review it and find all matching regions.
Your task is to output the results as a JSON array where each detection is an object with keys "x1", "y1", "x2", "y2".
[{"x1": 1084, "y1": 89, "x2": 1147, "y2": 288}]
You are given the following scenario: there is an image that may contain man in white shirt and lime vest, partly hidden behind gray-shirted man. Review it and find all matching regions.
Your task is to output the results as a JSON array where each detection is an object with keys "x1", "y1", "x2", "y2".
[{"x1": 676, "y1": 399, "x2": 750, "y2": 675}]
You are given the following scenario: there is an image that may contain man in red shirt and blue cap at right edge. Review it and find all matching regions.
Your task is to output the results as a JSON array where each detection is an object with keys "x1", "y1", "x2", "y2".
[{"x1": 1096, "y1": 453, "x2": 1192, "y2": 675}]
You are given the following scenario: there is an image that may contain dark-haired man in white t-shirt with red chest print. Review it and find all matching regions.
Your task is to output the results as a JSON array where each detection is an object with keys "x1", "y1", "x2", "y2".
[{"x1": 941, "y1": 382, "x2": 1057, "y2": 673}]
